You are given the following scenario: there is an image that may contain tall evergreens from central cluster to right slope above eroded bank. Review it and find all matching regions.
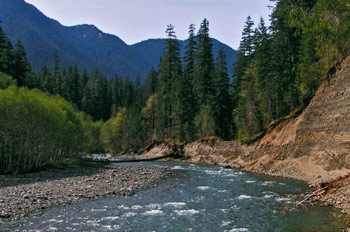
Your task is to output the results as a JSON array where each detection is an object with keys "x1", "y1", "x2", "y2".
[{"x1": 98, "y1": 0, "x2": 350, "y2": 153}]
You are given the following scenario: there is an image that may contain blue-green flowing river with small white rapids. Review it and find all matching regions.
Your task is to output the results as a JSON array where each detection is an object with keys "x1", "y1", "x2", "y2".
[{"x1": 3, "y1": 162, "x2": 348, "y2": 232}]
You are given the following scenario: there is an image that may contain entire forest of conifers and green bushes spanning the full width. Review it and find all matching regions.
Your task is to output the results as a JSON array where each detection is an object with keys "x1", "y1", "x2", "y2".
[{"x1": 0, "y1": 0, "x2": 350, "y2": 174}]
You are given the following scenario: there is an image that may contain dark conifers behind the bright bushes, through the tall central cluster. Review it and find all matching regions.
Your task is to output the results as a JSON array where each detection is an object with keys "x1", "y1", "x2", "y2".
[{"x1": 3, "y1": 19, "x2": 235, "y2": 154}]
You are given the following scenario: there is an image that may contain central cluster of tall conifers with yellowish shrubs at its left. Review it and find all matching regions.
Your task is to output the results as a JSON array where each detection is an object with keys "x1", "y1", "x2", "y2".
[{"x1": 101, "y1": 19, "x2": 235, "y2": 153}]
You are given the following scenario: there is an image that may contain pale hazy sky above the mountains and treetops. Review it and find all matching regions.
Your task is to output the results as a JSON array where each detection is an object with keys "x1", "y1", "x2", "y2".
[{"x1": 25, "y1": 0, "x2": 272, "y2": 49}]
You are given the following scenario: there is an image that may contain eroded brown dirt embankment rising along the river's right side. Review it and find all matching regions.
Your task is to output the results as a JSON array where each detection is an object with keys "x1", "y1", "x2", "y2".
[{"x1": 144, "y1": 56, "x2": 350, "y2": 212}]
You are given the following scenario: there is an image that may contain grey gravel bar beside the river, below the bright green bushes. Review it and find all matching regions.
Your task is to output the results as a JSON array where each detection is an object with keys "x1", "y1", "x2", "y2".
[{"x1": 0, "y1": 162, "x2": 171, "y2": 225}]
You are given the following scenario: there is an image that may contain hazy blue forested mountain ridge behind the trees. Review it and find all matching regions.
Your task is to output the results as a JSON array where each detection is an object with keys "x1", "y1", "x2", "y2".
[{"x1": 0, "y1": 0, "x2": 236, "y2": 80}]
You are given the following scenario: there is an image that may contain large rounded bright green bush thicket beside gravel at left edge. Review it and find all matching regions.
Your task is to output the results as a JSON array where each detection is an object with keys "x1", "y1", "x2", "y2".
[{"x1": 0, "y1": 86, "x2": 83, "y2": 173}]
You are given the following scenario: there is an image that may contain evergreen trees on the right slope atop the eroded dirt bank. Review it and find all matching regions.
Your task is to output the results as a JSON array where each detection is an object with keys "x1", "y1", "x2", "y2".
[{"x1": 233, "y1": 0, "x2": 350, "y2": 141}]
